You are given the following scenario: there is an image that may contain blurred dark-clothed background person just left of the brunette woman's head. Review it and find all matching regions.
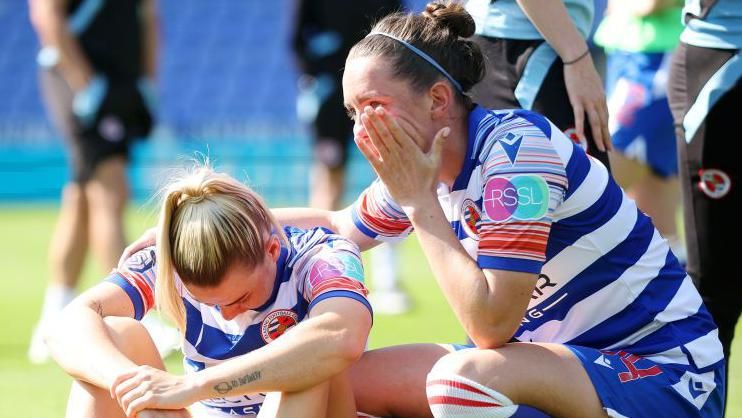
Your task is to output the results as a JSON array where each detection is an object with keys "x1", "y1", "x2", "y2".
[{"x1": 292, "y1": 0, "x2": 410, "y2": 314}]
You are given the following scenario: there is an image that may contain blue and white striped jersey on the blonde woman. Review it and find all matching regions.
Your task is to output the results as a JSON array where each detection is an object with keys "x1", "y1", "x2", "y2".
[{"x1": 107, "y1": 227, "x2": 371, "y2": 416}]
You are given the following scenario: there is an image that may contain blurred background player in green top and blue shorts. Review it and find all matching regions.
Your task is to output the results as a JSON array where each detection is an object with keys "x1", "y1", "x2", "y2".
[{"x1": 595, "y1": 0, "x2": 685, "y2": 262}]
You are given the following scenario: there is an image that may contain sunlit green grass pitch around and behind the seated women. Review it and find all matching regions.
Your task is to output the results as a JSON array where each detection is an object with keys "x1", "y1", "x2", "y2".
[{"x1": 0, "y1": 205, "x2": 742, "y2": 418}]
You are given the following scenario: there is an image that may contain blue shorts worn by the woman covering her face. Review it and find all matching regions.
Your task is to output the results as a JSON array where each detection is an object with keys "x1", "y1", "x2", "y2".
[{"x1": 567, "y1": 345, "x2": 725, "y2": 418}]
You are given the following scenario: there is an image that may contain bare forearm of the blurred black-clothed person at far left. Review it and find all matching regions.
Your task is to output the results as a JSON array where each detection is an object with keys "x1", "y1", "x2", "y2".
[{"x1": 30, "y1": 0, "x2": 93, "y2": 91}]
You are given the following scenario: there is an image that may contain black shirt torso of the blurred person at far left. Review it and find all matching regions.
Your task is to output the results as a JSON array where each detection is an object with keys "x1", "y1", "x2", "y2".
[{"x1": 67, "y1": 0, "x2": 144, "y2": 80}]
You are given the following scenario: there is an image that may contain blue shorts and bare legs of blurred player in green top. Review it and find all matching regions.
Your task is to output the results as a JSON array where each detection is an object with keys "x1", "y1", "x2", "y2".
[{"x1": 606, "y1": 51, "x2": 686, "y2": 263}]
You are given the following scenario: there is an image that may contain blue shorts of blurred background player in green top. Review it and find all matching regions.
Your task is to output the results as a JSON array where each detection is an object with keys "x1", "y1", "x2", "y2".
[{"x1": 606, "y1": 51, "x2": 678, "y2": 178}]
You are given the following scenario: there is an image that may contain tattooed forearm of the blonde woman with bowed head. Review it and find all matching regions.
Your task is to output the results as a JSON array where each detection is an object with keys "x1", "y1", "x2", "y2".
[{"x1": 196, "y1": 314, "x2": 370, "y2": 399}]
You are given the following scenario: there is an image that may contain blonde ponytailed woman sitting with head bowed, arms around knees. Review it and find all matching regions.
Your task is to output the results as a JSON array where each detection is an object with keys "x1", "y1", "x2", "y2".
[{"x1": 47, "y1": 166, "x2": 372, "y2": 418}]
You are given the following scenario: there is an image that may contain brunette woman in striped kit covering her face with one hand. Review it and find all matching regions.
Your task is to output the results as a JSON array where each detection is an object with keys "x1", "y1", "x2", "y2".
[{"x1": 274, "y1": 3, "x2": 725, "y2": 418}]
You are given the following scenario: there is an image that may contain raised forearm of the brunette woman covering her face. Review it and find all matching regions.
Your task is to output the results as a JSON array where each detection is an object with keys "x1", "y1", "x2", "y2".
[{"x1": 405, "y1": 201, "x2": 513, "y2": 346}]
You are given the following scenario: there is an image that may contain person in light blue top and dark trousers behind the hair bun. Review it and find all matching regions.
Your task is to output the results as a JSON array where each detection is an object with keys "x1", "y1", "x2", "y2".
[{"x1": 466, "y1": 0, "x2": 611, "y2": 167}]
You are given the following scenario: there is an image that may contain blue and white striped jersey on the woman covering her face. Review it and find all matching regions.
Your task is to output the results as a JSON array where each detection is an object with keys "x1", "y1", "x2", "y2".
[{"x1": 352, "y1": 107, "x2": 723, "y2": 369}]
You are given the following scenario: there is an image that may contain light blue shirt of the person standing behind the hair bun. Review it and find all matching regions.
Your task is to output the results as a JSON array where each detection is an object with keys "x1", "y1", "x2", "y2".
[{"x1": 466, "y1": 0, "x2": 595, "y2": 39}]
